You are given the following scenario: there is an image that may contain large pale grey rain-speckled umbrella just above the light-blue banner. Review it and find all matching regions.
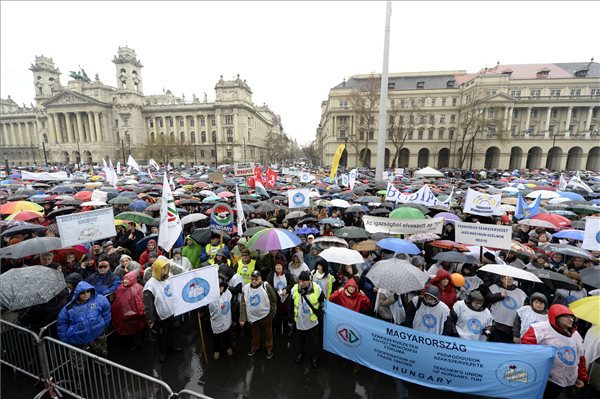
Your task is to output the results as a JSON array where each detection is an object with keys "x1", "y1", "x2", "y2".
[{"x1": 367, "y1": 258, "x2": 429, "y2": 295}]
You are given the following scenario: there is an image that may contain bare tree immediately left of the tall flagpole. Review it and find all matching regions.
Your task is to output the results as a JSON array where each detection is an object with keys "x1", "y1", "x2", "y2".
[{"x1": 348, "y1": 73, "x2": 381, "y2": 166}]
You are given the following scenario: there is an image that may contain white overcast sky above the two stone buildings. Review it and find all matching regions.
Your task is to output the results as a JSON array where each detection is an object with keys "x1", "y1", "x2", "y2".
[{"x1": 0, "y1": 0, "x2": 600, "y2": 144}]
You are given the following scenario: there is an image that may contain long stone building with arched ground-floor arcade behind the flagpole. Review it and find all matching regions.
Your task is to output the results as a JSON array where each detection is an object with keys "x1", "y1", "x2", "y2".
[{"x1": 314, "y1": 60, "x2": 600, "y2": 170}]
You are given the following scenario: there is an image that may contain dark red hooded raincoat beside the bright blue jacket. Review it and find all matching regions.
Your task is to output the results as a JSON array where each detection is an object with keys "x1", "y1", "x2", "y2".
[{"x1": 111, "y1": 270, "x2": 146, "y2": 335}]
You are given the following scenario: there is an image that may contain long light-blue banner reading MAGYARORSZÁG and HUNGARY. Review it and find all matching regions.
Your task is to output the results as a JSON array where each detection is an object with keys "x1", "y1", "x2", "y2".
[{"x1": 323, "y1": 302, "x2": 554, "y2": 399}]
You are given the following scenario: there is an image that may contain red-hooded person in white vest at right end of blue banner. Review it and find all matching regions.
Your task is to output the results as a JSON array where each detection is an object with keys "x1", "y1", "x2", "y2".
[{"x1": 521, "y1": 304, "x2": 588, "y2": 399}]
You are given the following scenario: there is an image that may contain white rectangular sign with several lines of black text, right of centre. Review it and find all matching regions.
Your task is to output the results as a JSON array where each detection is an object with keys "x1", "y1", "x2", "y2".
[{"x1": 454, "y1": 222, "x2": 512, "y2": 249}]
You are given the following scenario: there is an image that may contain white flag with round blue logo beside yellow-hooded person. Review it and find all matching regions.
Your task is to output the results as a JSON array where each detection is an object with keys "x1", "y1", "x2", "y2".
[{"x1": 169, "y1": 265, "x2": 221, "y2": 316}]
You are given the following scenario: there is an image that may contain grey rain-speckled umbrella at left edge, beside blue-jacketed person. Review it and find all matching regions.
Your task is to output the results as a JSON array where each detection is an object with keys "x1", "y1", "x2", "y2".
[{"x1": 0, "y1": 266, "x2": 67, "y2": 311}]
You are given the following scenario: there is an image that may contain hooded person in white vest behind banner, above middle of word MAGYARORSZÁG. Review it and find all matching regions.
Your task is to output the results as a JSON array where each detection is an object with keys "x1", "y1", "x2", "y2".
[{"x1": 405, "y1": 285, "x2": 452, "y2": 336}]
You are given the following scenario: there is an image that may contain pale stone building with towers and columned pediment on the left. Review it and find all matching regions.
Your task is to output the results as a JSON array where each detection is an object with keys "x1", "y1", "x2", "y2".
[{"x1": 0, "y1": 47, "x2": 285, "y2": 165}]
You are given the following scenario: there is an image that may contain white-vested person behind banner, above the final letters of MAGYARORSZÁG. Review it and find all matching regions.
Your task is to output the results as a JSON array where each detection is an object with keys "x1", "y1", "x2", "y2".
[{"x1": 450, "y1": 291, "x2": 494, "y2": 341}]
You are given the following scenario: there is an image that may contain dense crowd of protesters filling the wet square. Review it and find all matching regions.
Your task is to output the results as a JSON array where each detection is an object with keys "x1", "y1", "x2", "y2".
[{"x1": 0, "y1": 163, "x2": 600, "y2": 398}]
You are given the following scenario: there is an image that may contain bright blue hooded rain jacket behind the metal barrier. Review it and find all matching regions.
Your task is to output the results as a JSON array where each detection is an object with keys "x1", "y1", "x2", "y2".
[{"x1": 56, "y1": 281, "x2": 110, "y2": 346}]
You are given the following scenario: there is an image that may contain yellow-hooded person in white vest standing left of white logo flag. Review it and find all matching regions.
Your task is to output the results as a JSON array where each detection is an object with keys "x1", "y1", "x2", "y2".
[{"x1": 144, "y1": 256, "x2": 182, "y2": 363}]
